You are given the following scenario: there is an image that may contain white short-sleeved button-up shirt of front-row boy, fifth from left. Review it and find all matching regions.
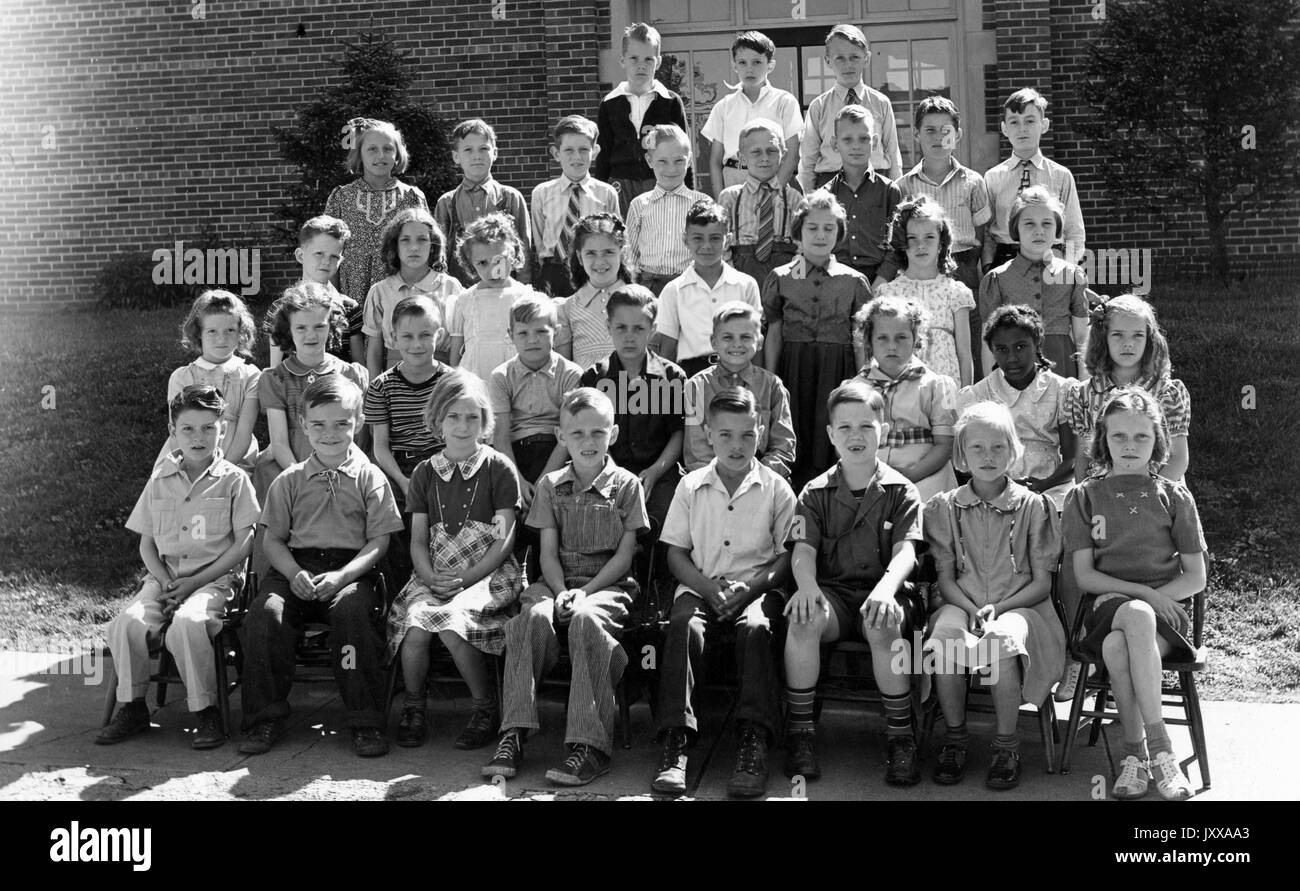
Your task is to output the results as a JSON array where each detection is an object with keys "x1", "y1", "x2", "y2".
[{"x1": 659, "y1": 460, "x2": 794, "y2": 596}]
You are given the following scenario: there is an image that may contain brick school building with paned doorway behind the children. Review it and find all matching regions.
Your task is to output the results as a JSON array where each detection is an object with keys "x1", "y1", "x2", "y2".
[{"x1": 0, "y1": 0, "x2": 1300, "y2": 310}]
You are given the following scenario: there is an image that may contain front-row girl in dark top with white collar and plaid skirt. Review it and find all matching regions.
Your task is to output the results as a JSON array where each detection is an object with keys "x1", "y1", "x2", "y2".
[{"x1": 389, "y1": 369, "x2": 524, "y2": 749}]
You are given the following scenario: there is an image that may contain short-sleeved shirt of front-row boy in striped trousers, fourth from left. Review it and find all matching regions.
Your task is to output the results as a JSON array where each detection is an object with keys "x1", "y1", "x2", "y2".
[{"x1": 528, "y1": 457, "x2": 650, "y2": 578}]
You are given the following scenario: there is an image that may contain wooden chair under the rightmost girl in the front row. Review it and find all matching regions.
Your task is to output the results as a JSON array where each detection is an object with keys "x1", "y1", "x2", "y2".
[{"x1": 1061, "y1": 591, "x2": 1210, "y2": 790}]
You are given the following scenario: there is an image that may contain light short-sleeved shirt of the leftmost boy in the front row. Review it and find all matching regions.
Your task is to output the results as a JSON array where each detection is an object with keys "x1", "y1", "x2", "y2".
[{"x1": 126, "y1": 450, "x2": 260, "y2": 578}]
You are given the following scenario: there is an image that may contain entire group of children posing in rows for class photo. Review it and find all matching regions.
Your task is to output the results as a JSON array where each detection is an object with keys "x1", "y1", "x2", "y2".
[{"x1": 99, "y1": 19, "x2": 1205, "y2": 799}]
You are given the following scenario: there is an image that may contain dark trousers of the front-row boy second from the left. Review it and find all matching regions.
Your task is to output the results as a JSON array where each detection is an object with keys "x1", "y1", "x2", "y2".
[{"x1": 241, "y1": 549, "x2": 387, "y2": 727}]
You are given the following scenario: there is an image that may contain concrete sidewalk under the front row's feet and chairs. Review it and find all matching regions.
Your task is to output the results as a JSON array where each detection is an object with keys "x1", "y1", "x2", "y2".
[{"x1": 0, "y1": 653, "x2": 1300, "y2": 801}]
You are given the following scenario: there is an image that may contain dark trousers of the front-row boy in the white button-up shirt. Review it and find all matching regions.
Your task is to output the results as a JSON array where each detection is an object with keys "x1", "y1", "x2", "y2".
[{"x1": 659, "y1": 591, "x2": 785, "y2": 741}]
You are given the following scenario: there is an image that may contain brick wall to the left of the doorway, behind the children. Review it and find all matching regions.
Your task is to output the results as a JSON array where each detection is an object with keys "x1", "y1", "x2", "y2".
[{"x1": 0, "y1": 0, "x2": 608, "y2": 310}]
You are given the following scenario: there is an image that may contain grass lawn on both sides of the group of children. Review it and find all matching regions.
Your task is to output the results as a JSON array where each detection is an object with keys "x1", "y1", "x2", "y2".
[{"x1": 0, "y1": 281, "x2": 1300, "y2": 701}]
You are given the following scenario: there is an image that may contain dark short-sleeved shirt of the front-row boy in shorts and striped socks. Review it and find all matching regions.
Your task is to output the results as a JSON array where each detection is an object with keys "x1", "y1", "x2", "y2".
[{"x1": 787, "y1": 460, "x2": 924, "y2": 597}]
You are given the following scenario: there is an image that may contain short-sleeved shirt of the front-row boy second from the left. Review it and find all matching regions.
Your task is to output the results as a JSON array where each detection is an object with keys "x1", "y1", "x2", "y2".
[{"x1": 261, "y1": 445, "x2": 403, "y2": 550}]
